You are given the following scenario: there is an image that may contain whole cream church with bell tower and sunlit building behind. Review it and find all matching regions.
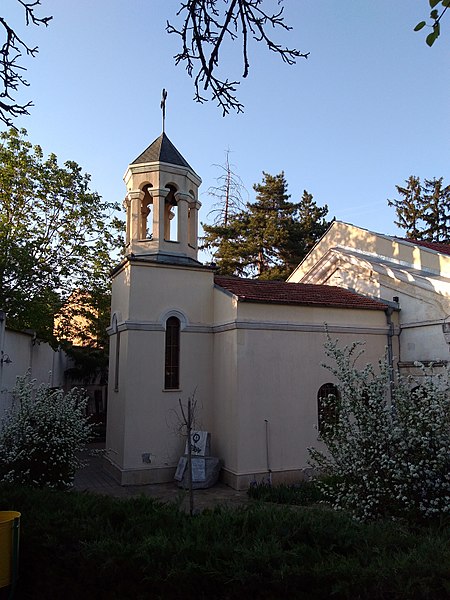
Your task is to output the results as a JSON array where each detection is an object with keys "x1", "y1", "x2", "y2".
[{"x1": 106, "y1": 133, "x2": 450, "y2": 489}]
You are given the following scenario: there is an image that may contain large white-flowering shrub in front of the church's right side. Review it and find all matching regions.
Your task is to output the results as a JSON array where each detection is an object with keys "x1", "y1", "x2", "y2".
[{"x1": 310, "y1": 338, "x2": 450, "y2": 520}]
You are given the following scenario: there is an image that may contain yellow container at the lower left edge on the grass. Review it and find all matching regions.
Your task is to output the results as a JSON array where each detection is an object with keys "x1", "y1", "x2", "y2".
[{"x1": 0, "y1": 510, "x2": 20, "y2": 588}]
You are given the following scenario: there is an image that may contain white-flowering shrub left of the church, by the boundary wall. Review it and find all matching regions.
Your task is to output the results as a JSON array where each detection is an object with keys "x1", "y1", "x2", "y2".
[{"x1": 0, "y1": 377, "x2": 92, "y2": 489}]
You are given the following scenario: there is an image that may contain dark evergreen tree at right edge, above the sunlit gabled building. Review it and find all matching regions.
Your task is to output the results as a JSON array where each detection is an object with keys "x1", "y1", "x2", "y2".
[{"x1": 388, "y1": 176, "x2": 450, "y2": 243}]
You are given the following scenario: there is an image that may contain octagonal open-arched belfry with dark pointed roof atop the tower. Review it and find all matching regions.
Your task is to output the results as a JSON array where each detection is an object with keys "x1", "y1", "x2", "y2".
[{"x1": 124, "y1": 131, "x2": 202, "y2": 264}]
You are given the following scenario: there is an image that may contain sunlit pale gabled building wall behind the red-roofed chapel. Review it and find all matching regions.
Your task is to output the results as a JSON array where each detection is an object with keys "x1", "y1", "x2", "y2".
[{"x1": 289, "y1": 222, "x2": 450, "y2": 372}]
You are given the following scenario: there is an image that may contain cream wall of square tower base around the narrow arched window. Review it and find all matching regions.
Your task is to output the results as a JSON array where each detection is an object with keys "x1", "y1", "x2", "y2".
[{"x1": 107, "y1": 262, "x2": 213, "y2": 483}]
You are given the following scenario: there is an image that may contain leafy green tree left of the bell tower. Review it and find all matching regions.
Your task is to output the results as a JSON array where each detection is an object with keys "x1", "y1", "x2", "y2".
[{"x1": 0, "y1": 130, "x2": 122, "y2": 341}]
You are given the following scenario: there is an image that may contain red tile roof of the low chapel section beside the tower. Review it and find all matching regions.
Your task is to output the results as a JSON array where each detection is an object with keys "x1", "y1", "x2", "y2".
[{"x1": 214, "y1": 275, "x2": 386, "y2": 310}]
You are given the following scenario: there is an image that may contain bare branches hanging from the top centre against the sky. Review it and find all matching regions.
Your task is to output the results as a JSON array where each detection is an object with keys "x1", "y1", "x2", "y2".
[{"x1": 166, "y1": 0, "x2": 309, "y2": 116}]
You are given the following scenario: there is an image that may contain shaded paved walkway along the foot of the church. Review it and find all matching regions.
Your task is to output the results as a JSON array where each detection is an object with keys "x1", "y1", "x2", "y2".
[{"x1": 74, "y1": 444, "x2": 249, "y2": 511}]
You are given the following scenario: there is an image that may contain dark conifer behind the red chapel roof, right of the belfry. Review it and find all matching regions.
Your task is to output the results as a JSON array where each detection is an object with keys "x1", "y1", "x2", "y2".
[{"x1": 203, "y1": 173, "x2": 329, "y2": 279}]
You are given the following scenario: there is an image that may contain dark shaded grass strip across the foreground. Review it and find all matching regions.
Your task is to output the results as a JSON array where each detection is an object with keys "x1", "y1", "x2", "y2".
[{"x1": 0, "y1": 487, "x2": 450, "y2": 600}]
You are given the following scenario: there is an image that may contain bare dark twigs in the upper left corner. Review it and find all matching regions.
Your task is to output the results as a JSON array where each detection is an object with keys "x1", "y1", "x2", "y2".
[{"x1": 0, "y1": 0, "x2": 53, "y2": 127}]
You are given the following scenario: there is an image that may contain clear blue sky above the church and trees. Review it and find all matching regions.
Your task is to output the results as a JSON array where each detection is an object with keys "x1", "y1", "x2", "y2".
[{"x1": 5, "y1": 0, "x2": 450, "y2": 258}]
